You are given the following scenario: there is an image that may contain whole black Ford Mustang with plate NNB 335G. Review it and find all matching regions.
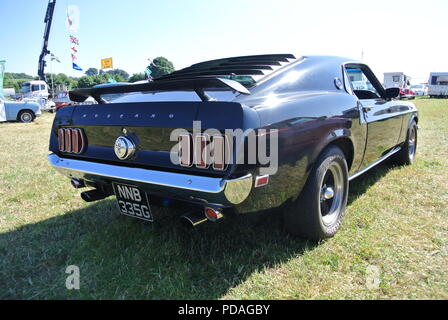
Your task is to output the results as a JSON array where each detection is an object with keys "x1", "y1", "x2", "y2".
[{"x1": 48, "y1": 54, "x2": 418, "y2": 239}]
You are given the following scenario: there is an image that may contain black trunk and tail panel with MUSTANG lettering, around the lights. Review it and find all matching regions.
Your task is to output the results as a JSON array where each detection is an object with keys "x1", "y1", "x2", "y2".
[{"x1": 50, "y1": 101, "x2": 255, "y2": 176}]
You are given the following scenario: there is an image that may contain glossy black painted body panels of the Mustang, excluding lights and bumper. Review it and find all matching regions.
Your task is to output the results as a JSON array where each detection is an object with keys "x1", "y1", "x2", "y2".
[{"x1": 50, "y1": 57, "x2": 417, "y2": 213}]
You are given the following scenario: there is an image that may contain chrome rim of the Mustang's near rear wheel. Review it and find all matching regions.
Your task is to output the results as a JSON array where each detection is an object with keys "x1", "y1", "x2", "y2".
[{"x1": 319, "y1": 162, "x2": 345, "y2": 226}]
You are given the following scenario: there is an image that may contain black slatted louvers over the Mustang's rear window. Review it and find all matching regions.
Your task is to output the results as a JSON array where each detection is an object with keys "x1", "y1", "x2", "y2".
[{"x1": 154, "y1": 54, "x2": 296, "y2": 86}]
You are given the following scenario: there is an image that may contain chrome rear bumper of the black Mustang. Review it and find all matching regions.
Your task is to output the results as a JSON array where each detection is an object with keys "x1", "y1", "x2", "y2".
[{"x1": 48, "y1": 153, "x2": 253, "y2": 207}]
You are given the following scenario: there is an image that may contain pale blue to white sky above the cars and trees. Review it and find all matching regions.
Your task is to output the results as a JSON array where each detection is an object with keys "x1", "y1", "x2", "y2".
[{"x1": 0, "y1": 0, "x2": 448, "y2": 81}]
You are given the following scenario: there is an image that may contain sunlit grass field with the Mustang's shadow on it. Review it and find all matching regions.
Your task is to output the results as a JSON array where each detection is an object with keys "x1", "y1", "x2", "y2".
[{"x1": 0, "y1": 99, "x2": 448, "y2": 299}]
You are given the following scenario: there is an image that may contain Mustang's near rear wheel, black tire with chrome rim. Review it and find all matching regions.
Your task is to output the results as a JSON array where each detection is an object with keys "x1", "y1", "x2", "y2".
[{"x1": 284, "y1": 146, "x2": 349, "y2": 240}]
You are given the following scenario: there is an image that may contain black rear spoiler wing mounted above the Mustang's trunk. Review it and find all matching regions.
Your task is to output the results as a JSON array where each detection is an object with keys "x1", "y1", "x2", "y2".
[{"x1": 69, "y1": 77, "x2": 250, "y2": 103}]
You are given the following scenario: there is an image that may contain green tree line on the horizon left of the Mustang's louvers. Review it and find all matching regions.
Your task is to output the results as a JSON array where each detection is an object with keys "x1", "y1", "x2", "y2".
[{"x1": 3, "y1": 57, "x2": 175, "y2": 93}]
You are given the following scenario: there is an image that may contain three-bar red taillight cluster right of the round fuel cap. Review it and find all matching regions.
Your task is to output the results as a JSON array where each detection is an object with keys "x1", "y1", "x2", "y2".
[{"x1": 179, "y1": 134, "x2": 228, "y2": 171}]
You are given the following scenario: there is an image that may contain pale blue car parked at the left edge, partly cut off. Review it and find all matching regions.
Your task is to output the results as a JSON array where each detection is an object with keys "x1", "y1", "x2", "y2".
[{"x1": 0, "y1": 95, "x2": 41, "y2": 122}]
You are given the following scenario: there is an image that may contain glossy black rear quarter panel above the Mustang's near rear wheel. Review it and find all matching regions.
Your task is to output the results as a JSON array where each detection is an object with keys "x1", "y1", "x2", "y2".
[{"x1": 237, "y1": 91, "x2": 367, "y2": 212}]
